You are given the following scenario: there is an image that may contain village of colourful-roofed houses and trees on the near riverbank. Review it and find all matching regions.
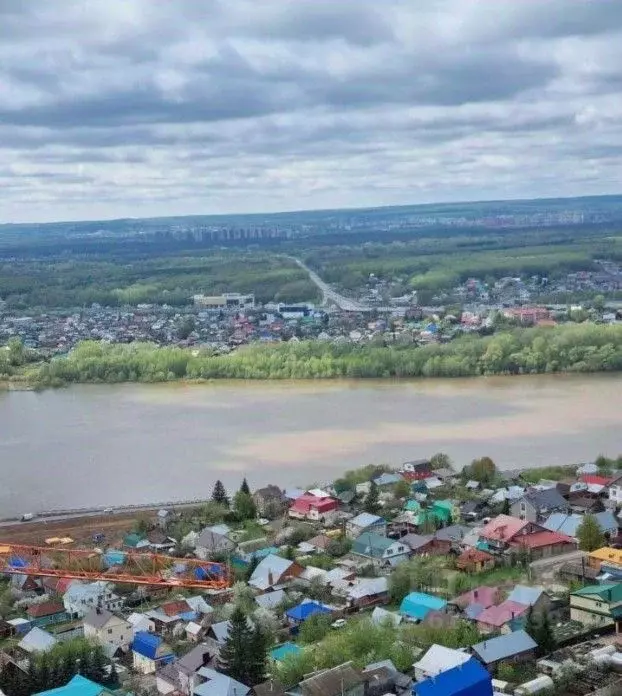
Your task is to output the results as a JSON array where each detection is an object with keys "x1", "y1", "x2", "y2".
[{"x1": 0, "y1": 454, "x2": 622, "y2": 696}]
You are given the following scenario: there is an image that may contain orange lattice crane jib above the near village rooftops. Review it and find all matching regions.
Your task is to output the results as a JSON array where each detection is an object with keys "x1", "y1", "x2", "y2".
[{"x1": 0, "y1": 542, "x2": 231, "y2": 590}]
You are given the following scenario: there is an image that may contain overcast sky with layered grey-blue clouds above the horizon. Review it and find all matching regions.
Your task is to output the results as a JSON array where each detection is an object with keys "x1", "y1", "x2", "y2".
[{"x1": 0, "y1": 0, "x2": 622, "y2": 222}]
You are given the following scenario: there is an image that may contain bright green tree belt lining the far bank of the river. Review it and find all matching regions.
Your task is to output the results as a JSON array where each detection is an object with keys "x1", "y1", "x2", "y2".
[{"x1": 18, "y1": 322, "x2": 622, "y2": 387}]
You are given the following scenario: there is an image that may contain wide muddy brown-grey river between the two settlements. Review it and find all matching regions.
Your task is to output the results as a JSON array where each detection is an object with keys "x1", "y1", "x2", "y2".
[{"x1": 0, "y1": 375, "x2": 622, "y2": 517}]
